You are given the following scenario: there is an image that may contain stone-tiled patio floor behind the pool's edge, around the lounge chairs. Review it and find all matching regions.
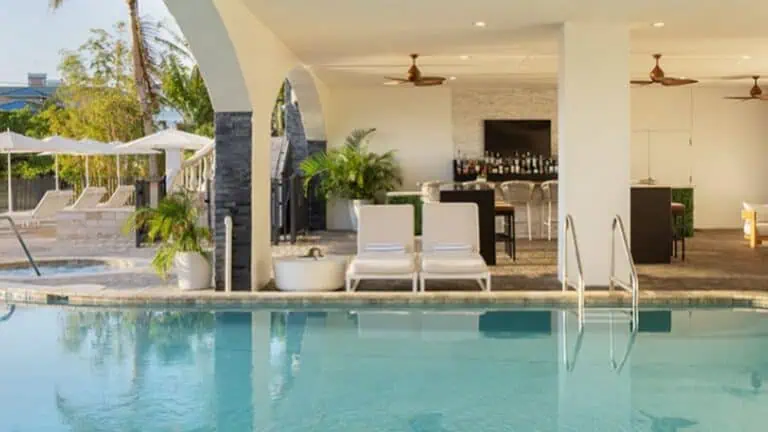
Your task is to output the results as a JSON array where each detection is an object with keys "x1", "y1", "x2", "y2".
[{"x1": 0, "y1": 226, "x2": 768, "y2": 292}]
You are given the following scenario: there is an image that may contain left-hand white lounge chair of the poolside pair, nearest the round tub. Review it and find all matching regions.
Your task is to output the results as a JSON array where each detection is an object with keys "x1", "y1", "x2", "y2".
[{"x1": 346, "y1": 204, "x2": 418, "y2": 292}]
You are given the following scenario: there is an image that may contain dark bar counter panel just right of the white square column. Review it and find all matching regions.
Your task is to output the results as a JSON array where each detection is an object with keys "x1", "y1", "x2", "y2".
[{"x1": 630, "y1": 187, "x2": 672, "y2": 264}]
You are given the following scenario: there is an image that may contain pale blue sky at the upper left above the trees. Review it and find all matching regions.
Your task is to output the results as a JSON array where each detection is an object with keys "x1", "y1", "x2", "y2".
[{"x1": 0, "y1": 0, "x2": 176, "y2": 86}]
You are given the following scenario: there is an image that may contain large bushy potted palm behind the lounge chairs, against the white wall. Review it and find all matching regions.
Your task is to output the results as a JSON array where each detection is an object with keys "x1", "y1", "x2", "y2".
[{"x1": 301, "y1": 129, "x2": 403, "y2": 230}]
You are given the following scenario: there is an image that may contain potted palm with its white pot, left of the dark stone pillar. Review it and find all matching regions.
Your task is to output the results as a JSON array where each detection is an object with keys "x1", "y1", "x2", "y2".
[{"x1": 124, "y1": 192, "x2": 211, "y2": 290}]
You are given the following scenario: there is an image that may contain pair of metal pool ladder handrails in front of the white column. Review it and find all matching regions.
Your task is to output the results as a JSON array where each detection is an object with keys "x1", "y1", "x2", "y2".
[{"x1": 562, "y1": 214, "x2": 640, "y2": 331}]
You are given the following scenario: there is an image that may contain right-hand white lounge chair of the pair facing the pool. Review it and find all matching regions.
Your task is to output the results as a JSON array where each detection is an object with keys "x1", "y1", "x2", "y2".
[{"x1": 419, "y1": 203, "x2": 491, "y2": 292}]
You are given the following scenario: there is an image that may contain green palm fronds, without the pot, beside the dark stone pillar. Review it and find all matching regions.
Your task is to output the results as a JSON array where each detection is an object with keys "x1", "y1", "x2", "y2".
[{"x1": 123, "y1": 192, "x2": 211, "y2": 278}]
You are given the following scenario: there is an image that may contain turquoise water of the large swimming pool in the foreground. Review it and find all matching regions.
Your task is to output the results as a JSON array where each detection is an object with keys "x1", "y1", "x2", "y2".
[{"x1": 0, "y1": 305, "x2": 768, "y2": 432}]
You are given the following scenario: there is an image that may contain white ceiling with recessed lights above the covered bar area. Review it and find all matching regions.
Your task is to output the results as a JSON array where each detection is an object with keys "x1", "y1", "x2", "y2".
[{"x1": 243, "y1": 0, "x2": 768, "y2": 88}]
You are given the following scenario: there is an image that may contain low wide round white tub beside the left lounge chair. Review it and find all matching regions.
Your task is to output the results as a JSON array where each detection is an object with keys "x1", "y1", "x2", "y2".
[{"x1": 274, "y1": 255, "x2": 347, "y2": 291}]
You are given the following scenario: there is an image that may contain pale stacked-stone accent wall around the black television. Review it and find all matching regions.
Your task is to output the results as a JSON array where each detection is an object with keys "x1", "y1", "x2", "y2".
[{"x1": 452, "y1": 85, "x2": 557, "y2": 156}]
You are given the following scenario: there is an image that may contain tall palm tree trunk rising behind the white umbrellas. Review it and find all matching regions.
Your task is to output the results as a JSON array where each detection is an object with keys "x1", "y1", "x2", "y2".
[{"x1": 50, "y1": 0, "x2": 157, "y2": 176}]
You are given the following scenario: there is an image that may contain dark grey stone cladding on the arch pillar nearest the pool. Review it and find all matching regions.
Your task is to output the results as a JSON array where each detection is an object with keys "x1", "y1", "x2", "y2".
[{"x1": 213, "y1": 111, "x2": 253, "y2": 291}]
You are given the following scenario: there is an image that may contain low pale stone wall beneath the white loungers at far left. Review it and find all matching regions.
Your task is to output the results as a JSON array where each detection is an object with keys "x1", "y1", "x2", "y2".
[{"x1": 56, "y1": 208, "x2": 134, "y2": 240}]
